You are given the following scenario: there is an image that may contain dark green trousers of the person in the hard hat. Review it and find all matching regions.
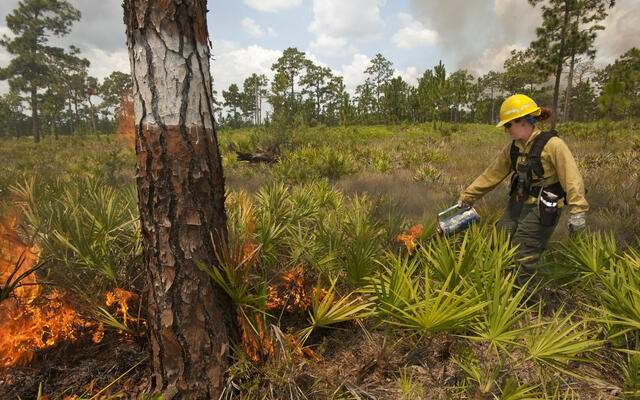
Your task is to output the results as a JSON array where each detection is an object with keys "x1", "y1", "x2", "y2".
[{"x1": 498, "y1": 204, "x2": 560, "y2": 274}]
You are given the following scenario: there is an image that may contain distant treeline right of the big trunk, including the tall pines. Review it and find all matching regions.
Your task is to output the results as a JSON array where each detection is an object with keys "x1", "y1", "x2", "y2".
[{"x1": 218, "y1": 0, "x2": 640, "y2": 127}]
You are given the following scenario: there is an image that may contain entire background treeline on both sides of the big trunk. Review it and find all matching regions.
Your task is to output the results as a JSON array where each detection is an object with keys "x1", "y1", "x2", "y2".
[{"x1": 0, "y1": 0, "x2": 640, "y2": 141}]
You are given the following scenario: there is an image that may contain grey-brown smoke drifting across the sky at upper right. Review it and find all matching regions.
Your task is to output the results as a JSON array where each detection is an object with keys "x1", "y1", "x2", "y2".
[{"x1": 410, "y1": 0, "x2": 640, "y2": 74}]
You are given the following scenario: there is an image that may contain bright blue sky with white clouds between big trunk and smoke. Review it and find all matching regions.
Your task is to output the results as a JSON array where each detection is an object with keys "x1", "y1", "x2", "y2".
[{"x1": 209, "y1": 0, "x2": 448, "y2": 89}]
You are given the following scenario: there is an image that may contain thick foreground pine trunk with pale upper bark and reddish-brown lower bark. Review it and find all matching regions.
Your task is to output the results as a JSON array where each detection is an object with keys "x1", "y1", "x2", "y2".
[{"x1": 123, "y1": 0, "x2": 234, "y2": 399}]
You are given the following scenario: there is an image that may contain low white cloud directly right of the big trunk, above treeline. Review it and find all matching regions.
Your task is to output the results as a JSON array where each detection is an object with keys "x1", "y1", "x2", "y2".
[{"x1": 211, "y1": 40, "x2": 282, "y2": 93}]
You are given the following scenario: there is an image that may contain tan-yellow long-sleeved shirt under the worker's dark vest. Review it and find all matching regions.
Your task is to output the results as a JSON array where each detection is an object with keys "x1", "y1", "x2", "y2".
[{"x1": 458, "y1": 130, "x2": 589, "y2": 214}]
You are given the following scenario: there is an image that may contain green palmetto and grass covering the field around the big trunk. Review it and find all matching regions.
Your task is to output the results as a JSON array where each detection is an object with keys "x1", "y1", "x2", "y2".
[{"x1": 0, "y1": 121, "x2": 640, "y2": 399}]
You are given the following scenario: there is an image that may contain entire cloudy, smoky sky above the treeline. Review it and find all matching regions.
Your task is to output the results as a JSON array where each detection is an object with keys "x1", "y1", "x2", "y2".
[{"x1": 0, "y1": 0, "x2": 640, "y2": 92}]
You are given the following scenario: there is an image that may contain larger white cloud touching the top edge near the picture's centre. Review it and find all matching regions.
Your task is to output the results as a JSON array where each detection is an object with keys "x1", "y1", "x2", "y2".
[{"x1": 309, "y1": 0, "x2": 384, "y2": 39}]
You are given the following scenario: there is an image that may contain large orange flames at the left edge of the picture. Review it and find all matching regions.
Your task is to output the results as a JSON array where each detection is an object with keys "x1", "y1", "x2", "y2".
[{"x1": 0, "y1": 214, "x2": 87, "y2": 367}]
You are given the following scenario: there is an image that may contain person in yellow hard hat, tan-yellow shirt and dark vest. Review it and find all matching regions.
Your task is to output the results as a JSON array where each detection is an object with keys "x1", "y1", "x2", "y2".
[{"x1": 458, "y1": 94, "x2": 589, "y2": 274}]
